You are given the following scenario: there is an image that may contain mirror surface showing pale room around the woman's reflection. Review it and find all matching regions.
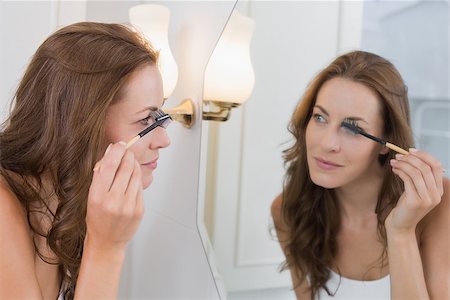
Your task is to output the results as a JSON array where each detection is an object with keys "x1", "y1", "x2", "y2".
[{"x1": 198, "y1": 1, "x2": 450, "y2": 299}]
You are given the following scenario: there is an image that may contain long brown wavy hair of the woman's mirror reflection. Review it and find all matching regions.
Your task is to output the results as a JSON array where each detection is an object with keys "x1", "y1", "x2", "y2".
[{"x1": 281, "y1": 51, "x2": 413, "y2": 297}]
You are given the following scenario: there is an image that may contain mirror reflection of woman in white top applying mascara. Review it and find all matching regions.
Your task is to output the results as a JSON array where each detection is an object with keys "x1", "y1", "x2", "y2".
[{"x1": 272, "y1": 51, "x2": 450, "y2": 299}]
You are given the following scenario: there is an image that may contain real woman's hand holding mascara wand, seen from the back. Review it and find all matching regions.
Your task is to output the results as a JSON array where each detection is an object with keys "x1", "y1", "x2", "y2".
[{"x1": 86, "y1": 142, "x2": 144, "y2": 250}]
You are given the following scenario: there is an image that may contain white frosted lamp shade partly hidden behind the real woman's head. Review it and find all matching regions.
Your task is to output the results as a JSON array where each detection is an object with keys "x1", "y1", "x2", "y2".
[{"x1": 129, "y1": 4, "x2": 178, "y2": 99}]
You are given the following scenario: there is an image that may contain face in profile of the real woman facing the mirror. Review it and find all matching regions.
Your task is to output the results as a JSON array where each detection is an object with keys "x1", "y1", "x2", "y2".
[{"x1": 106, "y1": 65, "x2": 170, "y2": 188}]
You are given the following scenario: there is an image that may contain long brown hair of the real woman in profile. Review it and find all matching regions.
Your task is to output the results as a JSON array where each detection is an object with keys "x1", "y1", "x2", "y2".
[{"x1": 0, "y1": 22, "x2": 158, "y2": 299}]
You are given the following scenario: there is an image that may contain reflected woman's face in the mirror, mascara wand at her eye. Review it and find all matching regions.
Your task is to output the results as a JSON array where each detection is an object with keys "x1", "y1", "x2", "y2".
[{"x1": 306, "y1": 77, "x2": 387, "y2": 188}]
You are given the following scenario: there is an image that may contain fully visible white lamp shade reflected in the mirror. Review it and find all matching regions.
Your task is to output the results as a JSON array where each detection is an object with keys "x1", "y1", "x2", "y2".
[{"x1": 203, "y1": 11, "x2": 255, "y2": 104}]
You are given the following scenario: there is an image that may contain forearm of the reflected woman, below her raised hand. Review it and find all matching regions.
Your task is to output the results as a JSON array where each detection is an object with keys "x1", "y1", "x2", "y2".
[{"x1": 387, "y1": 231, "x2": 429, "y2": 300}]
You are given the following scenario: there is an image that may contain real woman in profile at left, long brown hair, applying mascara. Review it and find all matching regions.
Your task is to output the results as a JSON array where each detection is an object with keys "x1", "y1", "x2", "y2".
[{"x1": 0, "y1": 22, "x2": 169, "y2": 299}]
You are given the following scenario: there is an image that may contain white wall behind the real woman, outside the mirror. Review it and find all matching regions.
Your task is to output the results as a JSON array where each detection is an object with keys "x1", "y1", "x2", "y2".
[{"x1": 0, "y1": 1, "x2": 234, "y2": 299}]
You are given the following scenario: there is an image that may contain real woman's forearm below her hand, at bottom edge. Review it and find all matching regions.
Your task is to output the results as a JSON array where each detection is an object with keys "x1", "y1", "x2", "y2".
[{"x1": 75, "y1": 238, "x2": 125, "y2": 299}]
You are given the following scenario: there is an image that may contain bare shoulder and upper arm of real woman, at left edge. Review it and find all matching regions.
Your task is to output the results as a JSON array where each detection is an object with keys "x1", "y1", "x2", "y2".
[{"x1": 0, "y1": 176, "x2": 40, "y2": 299}]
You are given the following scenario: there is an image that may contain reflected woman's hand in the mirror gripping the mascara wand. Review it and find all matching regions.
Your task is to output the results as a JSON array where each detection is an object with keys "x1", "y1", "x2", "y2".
[{"x1": 385, "y1": 149, "x2": 444, "y2": 233}]
